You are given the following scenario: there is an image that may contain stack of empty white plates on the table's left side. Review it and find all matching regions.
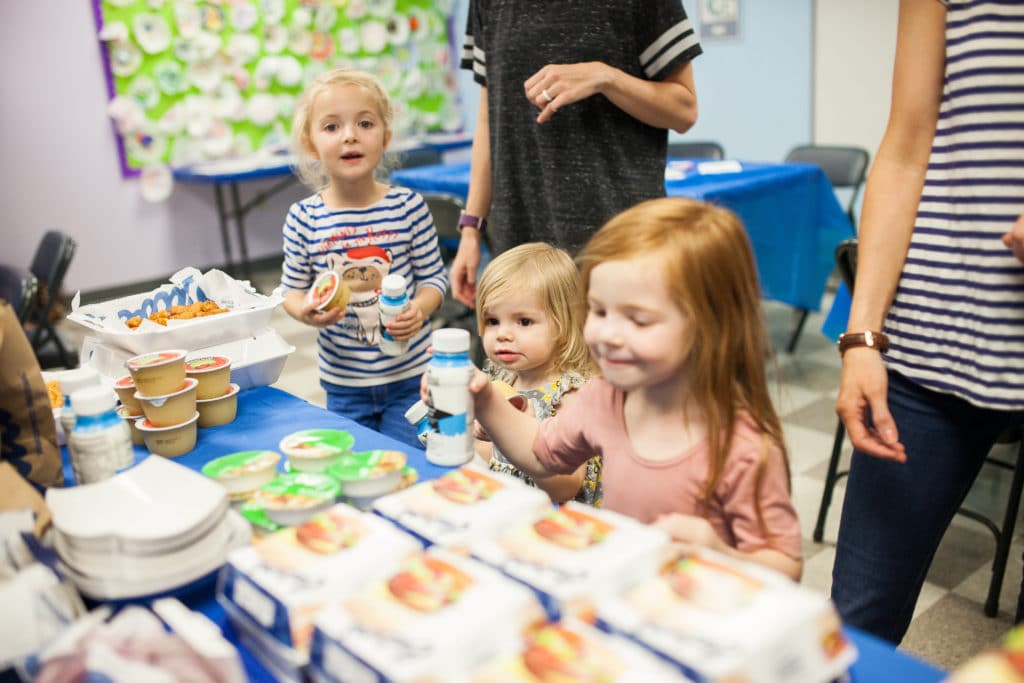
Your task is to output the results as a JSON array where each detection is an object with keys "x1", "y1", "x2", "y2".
[{"x1": 46, "y1": 456, "x2": 250, "y2": 600}]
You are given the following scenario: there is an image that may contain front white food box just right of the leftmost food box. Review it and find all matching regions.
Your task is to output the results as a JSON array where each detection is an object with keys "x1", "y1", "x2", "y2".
[{"x1": 309, "y1": 548, "x2": 544, "y2": 683}]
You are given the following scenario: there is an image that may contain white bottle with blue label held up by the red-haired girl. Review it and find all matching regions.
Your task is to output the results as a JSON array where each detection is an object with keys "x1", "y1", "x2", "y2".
[{"x1": 427, "y1": 328, "x2": 473, "y2": 467}]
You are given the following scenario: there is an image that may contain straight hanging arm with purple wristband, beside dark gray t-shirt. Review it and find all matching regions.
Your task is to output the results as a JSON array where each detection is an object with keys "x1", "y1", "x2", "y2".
[{"x1": 452, "y1": 85, "x2": 492, "y2": 308}]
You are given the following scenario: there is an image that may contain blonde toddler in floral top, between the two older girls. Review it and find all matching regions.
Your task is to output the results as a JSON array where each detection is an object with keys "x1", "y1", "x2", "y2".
[{"x1": 476, "y1": 242, "x2": 601, "y2": 505}]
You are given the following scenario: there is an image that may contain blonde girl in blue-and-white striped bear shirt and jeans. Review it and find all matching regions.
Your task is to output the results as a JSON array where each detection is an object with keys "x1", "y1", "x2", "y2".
[{"x1": 281, "y1": 69, "x2": 447, "y2": 449}]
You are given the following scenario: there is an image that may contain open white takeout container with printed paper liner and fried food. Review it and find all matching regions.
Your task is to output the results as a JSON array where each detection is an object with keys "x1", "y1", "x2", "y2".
[{"x1": 68, "y1": 267, "x2": 283, "y2": 355}]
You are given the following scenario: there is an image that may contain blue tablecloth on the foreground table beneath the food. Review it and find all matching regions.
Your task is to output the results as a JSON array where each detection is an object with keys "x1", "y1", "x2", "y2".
[{"x1": 65, "y1": 387, "x2": 945, "y2": 683}]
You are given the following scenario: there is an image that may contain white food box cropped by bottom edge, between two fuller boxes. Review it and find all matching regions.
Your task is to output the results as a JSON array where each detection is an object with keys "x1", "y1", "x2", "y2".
[{"x1": 466, "y1": 620, "x2": 690, "y2": 683}]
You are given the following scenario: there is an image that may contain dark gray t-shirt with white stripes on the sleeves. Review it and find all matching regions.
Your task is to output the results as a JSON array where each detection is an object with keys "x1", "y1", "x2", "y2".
[{"x1": 462, "y1": 0, "x2": 701, "y2": 253}]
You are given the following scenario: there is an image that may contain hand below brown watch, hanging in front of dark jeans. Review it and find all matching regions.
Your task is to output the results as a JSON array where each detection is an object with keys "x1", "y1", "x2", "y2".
[{"x1": 836, "y1": 348, "x2": 906, "y2": 463}]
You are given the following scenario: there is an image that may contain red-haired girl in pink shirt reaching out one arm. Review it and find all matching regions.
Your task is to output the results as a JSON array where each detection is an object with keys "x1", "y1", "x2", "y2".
[{"x1": 470, "y1": 194, "x2": 802, "y2": 579}]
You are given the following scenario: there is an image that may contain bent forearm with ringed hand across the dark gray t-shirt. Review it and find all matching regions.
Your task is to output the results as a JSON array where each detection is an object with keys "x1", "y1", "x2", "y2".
[{"x1": 524, "y1": 61, "x2": 697, "y2": 133}]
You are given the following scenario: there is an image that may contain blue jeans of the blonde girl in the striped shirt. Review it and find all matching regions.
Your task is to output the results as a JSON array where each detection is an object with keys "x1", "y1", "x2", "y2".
[{"x1": 321, "y1": 376, "x2": 423, "y2": 451}]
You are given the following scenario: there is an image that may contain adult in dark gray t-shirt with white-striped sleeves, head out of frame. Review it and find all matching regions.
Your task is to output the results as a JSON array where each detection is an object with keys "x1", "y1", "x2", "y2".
[{"x1": 452, "y1": 0, "x2": 701, "y2": 306}]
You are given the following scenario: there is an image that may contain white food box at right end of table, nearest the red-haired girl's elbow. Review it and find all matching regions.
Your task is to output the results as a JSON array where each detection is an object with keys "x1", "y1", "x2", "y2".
[{"x1": 596, "y1": 551, "x2": 856, "y2": 683}]
